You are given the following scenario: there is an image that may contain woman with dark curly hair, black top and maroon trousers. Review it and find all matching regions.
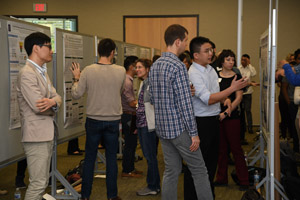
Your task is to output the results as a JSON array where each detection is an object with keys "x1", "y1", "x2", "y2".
[{"x1": 214, "y1": 49, "x2": 249, "y2": 191}]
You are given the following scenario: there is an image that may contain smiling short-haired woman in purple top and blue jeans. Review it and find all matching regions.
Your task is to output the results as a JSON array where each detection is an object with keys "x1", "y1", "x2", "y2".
[{"x1": 136, "y1": 59, "x2": 160, "y2": 196}]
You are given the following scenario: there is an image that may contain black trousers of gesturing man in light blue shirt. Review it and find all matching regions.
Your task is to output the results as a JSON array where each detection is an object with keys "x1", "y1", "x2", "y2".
[{"x1": 184, "y1": 116, "x2": 220, "y2": 200}]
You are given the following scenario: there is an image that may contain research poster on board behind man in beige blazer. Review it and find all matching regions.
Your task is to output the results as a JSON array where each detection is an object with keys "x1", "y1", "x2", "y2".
[{"x1": 7, "y1": 21, "x2": 44, "y2": 130}]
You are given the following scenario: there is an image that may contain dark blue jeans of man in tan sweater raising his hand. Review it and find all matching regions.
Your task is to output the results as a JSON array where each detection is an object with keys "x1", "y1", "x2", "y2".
[{"x1": 81, "y1": 117, "x2": 120, "y2": 198}]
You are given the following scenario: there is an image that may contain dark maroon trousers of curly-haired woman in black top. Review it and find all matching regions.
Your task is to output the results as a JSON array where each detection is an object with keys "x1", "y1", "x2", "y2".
[{"x1": 216, "y1": 119, "x2": 249, "y2": 185}]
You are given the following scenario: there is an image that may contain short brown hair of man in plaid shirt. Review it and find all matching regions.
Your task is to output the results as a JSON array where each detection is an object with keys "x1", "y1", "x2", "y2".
[{"x1": 165, "y1": 24, "x2": 188, "y2": 46}]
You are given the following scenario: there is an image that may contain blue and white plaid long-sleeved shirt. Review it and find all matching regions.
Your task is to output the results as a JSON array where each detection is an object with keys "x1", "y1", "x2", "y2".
[{"x1": 149, "y1": 52, "x2": 198, "y2": 139}]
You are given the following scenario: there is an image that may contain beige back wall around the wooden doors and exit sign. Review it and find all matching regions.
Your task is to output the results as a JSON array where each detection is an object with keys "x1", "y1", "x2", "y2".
[{"x1": 0, "y1": 0, "x2": 300, "y2": 125}]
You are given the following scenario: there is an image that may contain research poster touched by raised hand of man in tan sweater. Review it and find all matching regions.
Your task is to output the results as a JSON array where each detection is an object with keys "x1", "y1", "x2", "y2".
[{"x1": 63, "y1": 33, "x2": 84, "y2": 128}]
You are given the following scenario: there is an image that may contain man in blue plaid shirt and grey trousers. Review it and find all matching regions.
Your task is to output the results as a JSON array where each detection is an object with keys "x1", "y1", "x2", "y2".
[{"x1": 149, "y1": 24, "x2": 213, "y2": 200}]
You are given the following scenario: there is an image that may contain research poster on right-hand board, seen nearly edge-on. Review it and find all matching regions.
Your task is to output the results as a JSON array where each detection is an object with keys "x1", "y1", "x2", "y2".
[{"x1": 260, "y1": 30, "x2": 271, "y2": 135}]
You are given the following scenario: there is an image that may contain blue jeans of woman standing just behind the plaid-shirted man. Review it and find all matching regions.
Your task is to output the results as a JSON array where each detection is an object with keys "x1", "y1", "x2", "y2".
[{"x1": 138, "y1": 127, "x2": 160, "y2": 190}]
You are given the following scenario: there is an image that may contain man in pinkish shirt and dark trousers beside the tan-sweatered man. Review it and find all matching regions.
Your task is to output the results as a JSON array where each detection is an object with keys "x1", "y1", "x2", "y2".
[{"x1": 121, "y1": 56, "x2": 143, "y2": 178}]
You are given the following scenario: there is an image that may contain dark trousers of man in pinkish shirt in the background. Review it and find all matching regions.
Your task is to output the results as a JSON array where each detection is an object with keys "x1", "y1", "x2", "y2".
[{"x1": 121, "y1": 114, "x2": 137, "y2": 173}]
